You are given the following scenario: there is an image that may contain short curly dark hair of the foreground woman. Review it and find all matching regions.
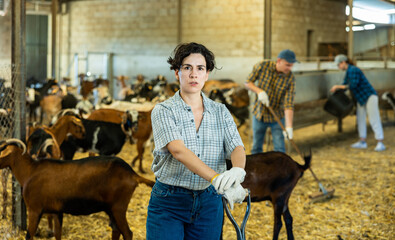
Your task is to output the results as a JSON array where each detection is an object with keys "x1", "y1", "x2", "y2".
[{"x1": 167, "y1": 42, "x2": 215, "y2": 72}]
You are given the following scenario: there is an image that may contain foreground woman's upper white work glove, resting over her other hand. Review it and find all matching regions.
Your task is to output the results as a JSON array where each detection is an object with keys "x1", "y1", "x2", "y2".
[{"x1": 211, "y1": 167, "x2": 246, "y2": 194}]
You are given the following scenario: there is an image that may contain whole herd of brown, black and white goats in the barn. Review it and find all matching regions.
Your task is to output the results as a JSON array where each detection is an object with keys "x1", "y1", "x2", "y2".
[{"x1": 0, "y1": 76, "x2": 394, "y2": 240}]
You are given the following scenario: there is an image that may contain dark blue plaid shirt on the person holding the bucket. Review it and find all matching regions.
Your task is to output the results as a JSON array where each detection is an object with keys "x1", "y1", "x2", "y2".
[{"x1": 343, "y1": 64, "x2": 377, "y2": 106}]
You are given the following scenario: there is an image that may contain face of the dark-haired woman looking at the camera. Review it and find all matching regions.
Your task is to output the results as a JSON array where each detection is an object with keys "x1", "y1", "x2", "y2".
[{"x1": 175, "y1": 53, "x2": 209, "y2": 93}]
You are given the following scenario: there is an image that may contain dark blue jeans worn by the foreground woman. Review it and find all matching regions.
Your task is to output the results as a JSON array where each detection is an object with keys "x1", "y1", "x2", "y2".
[{"x1": 146, "y1": 181, "x2": 224, "y2": 240}]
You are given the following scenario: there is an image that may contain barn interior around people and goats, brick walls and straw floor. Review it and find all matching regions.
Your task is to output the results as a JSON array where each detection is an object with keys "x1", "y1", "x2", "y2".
[{"x1": 0, "y1": 0, "x2": 395, "y2": 240}]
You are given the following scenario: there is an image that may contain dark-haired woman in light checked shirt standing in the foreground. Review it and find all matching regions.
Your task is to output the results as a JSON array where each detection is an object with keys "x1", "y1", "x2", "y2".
[{"x1": 146, "y1": 42, "x2": 246, "y2": 240}]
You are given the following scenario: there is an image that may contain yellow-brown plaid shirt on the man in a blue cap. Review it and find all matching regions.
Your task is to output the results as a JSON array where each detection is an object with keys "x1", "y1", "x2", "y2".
[{"x1": 247, "y1": 61, "x2": 295, "y2": 122}]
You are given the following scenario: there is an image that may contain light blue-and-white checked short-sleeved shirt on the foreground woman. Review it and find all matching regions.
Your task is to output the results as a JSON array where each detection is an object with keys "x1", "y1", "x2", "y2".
[{"x1": 151, "y1": 91, "x2": 244, "y2": 190}]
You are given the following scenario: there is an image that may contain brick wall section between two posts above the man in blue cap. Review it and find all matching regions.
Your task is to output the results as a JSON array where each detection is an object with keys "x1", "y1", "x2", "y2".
[{"x1": 272, "y1": 0, "x2": 347, "y2": 56}]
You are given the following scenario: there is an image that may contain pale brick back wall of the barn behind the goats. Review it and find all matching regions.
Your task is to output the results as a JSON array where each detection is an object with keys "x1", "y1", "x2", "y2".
[{"x1": 0, "y1": 0, "x2": 347, "y2": 86}]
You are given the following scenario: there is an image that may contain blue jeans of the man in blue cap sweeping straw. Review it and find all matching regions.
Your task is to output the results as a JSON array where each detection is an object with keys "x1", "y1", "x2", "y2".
[{"x1": 251, "y1": 116, "x2": 285, "y2": 154}]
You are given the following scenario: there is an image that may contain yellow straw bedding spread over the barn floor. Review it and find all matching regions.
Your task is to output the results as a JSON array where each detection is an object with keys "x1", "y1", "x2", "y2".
[{"x1": 0, "y1": 117, "x2": 395, "y2": 240}]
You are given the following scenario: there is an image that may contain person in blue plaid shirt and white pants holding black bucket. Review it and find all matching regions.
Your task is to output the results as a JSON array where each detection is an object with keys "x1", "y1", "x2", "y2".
[{"x1": 331, "y1": 54, "x2": 385, "y2": 151}]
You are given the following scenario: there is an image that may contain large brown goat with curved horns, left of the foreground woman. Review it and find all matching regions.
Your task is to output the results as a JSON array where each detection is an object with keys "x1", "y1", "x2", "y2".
[{"x1": 0, "y1": 139, "x2": 154, "y2": 240}]
